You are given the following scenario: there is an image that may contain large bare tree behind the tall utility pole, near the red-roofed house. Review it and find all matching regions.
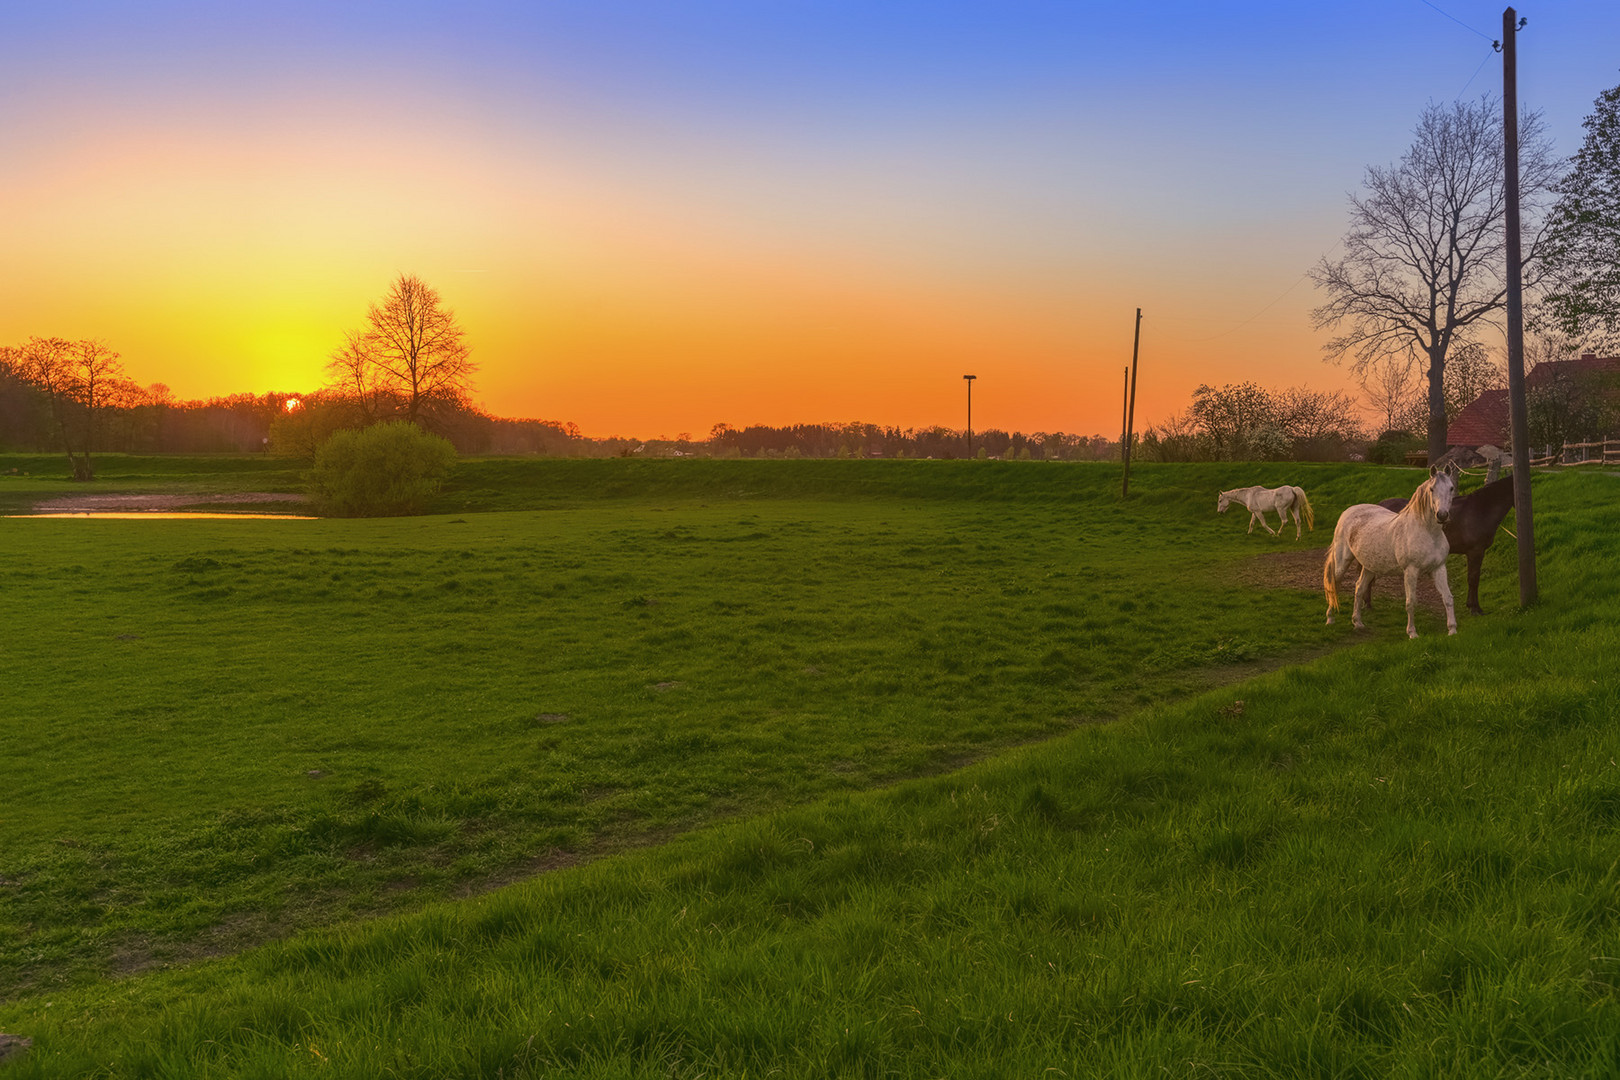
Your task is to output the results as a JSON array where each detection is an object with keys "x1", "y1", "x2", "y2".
[{"x1": 1311, "y1": 97, "x2": 1558, "y2": 460}]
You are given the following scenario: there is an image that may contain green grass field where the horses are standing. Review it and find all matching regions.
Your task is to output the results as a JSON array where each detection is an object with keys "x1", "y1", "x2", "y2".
[{"x1": 0, "y1": 461, "x2": 1620, "y2": 1077}]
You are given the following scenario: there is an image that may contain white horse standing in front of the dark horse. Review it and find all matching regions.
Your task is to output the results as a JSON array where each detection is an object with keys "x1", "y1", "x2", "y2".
[{"x1": 1322, "y1": 470, "x2": 1456, "y2": 638}]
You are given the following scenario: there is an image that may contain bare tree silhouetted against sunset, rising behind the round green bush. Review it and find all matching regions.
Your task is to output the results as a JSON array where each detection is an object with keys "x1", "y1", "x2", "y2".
[{"x1": 327, "y1": 274, "x2": 478, "y2": 426}]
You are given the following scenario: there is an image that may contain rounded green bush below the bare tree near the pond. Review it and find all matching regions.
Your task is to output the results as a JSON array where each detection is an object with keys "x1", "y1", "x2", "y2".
[{"x1": 309, "y1": 421, "x2": 455, "y2": 518}]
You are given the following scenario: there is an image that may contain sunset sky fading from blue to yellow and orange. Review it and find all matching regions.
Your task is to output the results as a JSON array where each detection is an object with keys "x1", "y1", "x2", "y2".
[{"x1": 0, "y1": 0, "x2": 1620, "y2": 437}]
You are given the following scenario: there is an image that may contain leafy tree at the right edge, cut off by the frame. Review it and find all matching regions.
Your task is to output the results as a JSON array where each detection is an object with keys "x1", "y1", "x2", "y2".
[{"x1": 1536, "y1": 86, "x2": 1620, "y2": 350}]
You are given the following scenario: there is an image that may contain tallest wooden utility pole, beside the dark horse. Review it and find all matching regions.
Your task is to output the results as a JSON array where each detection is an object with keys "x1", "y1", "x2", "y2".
[{"x1": 1502, "y1": 8, "x2": 1536, "y2": 607}]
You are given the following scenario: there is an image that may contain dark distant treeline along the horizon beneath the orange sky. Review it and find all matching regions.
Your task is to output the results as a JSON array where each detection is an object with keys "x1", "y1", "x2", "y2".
[{"x1": 0, "y1": 340, "x2": 1364, "y2": 461}]
